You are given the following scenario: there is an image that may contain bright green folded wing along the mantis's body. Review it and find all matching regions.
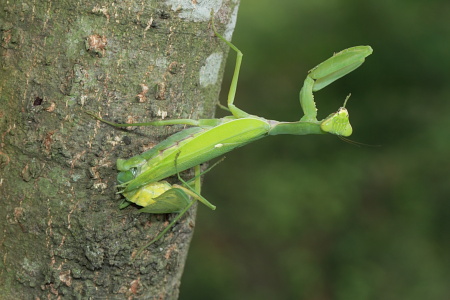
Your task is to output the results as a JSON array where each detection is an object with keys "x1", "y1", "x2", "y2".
[{"x1": 119, "y1": 118, "x2": 271, "y2": 192}]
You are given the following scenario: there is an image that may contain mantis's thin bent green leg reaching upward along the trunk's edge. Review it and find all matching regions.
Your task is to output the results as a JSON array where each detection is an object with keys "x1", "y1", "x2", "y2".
[{"x1": 211, "y1": 12, "x2": 249, "y2": 118}]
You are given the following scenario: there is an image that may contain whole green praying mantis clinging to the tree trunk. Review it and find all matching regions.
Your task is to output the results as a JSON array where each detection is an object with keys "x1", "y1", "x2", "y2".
[{"x1": 89, "y1": 22, "x2": 372, "y2": 251}]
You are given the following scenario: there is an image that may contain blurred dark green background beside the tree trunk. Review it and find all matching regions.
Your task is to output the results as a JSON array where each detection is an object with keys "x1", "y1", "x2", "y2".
[{"x1": 180, "y1": 0, "x2": 450, "y2": 300}]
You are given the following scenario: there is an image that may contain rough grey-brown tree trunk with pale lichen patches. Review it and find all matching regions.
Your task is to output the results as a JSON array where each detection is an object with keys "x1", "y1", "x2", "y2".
[{"x1": 0, "y1": 0, "x2": 238, "y2": 299}]
